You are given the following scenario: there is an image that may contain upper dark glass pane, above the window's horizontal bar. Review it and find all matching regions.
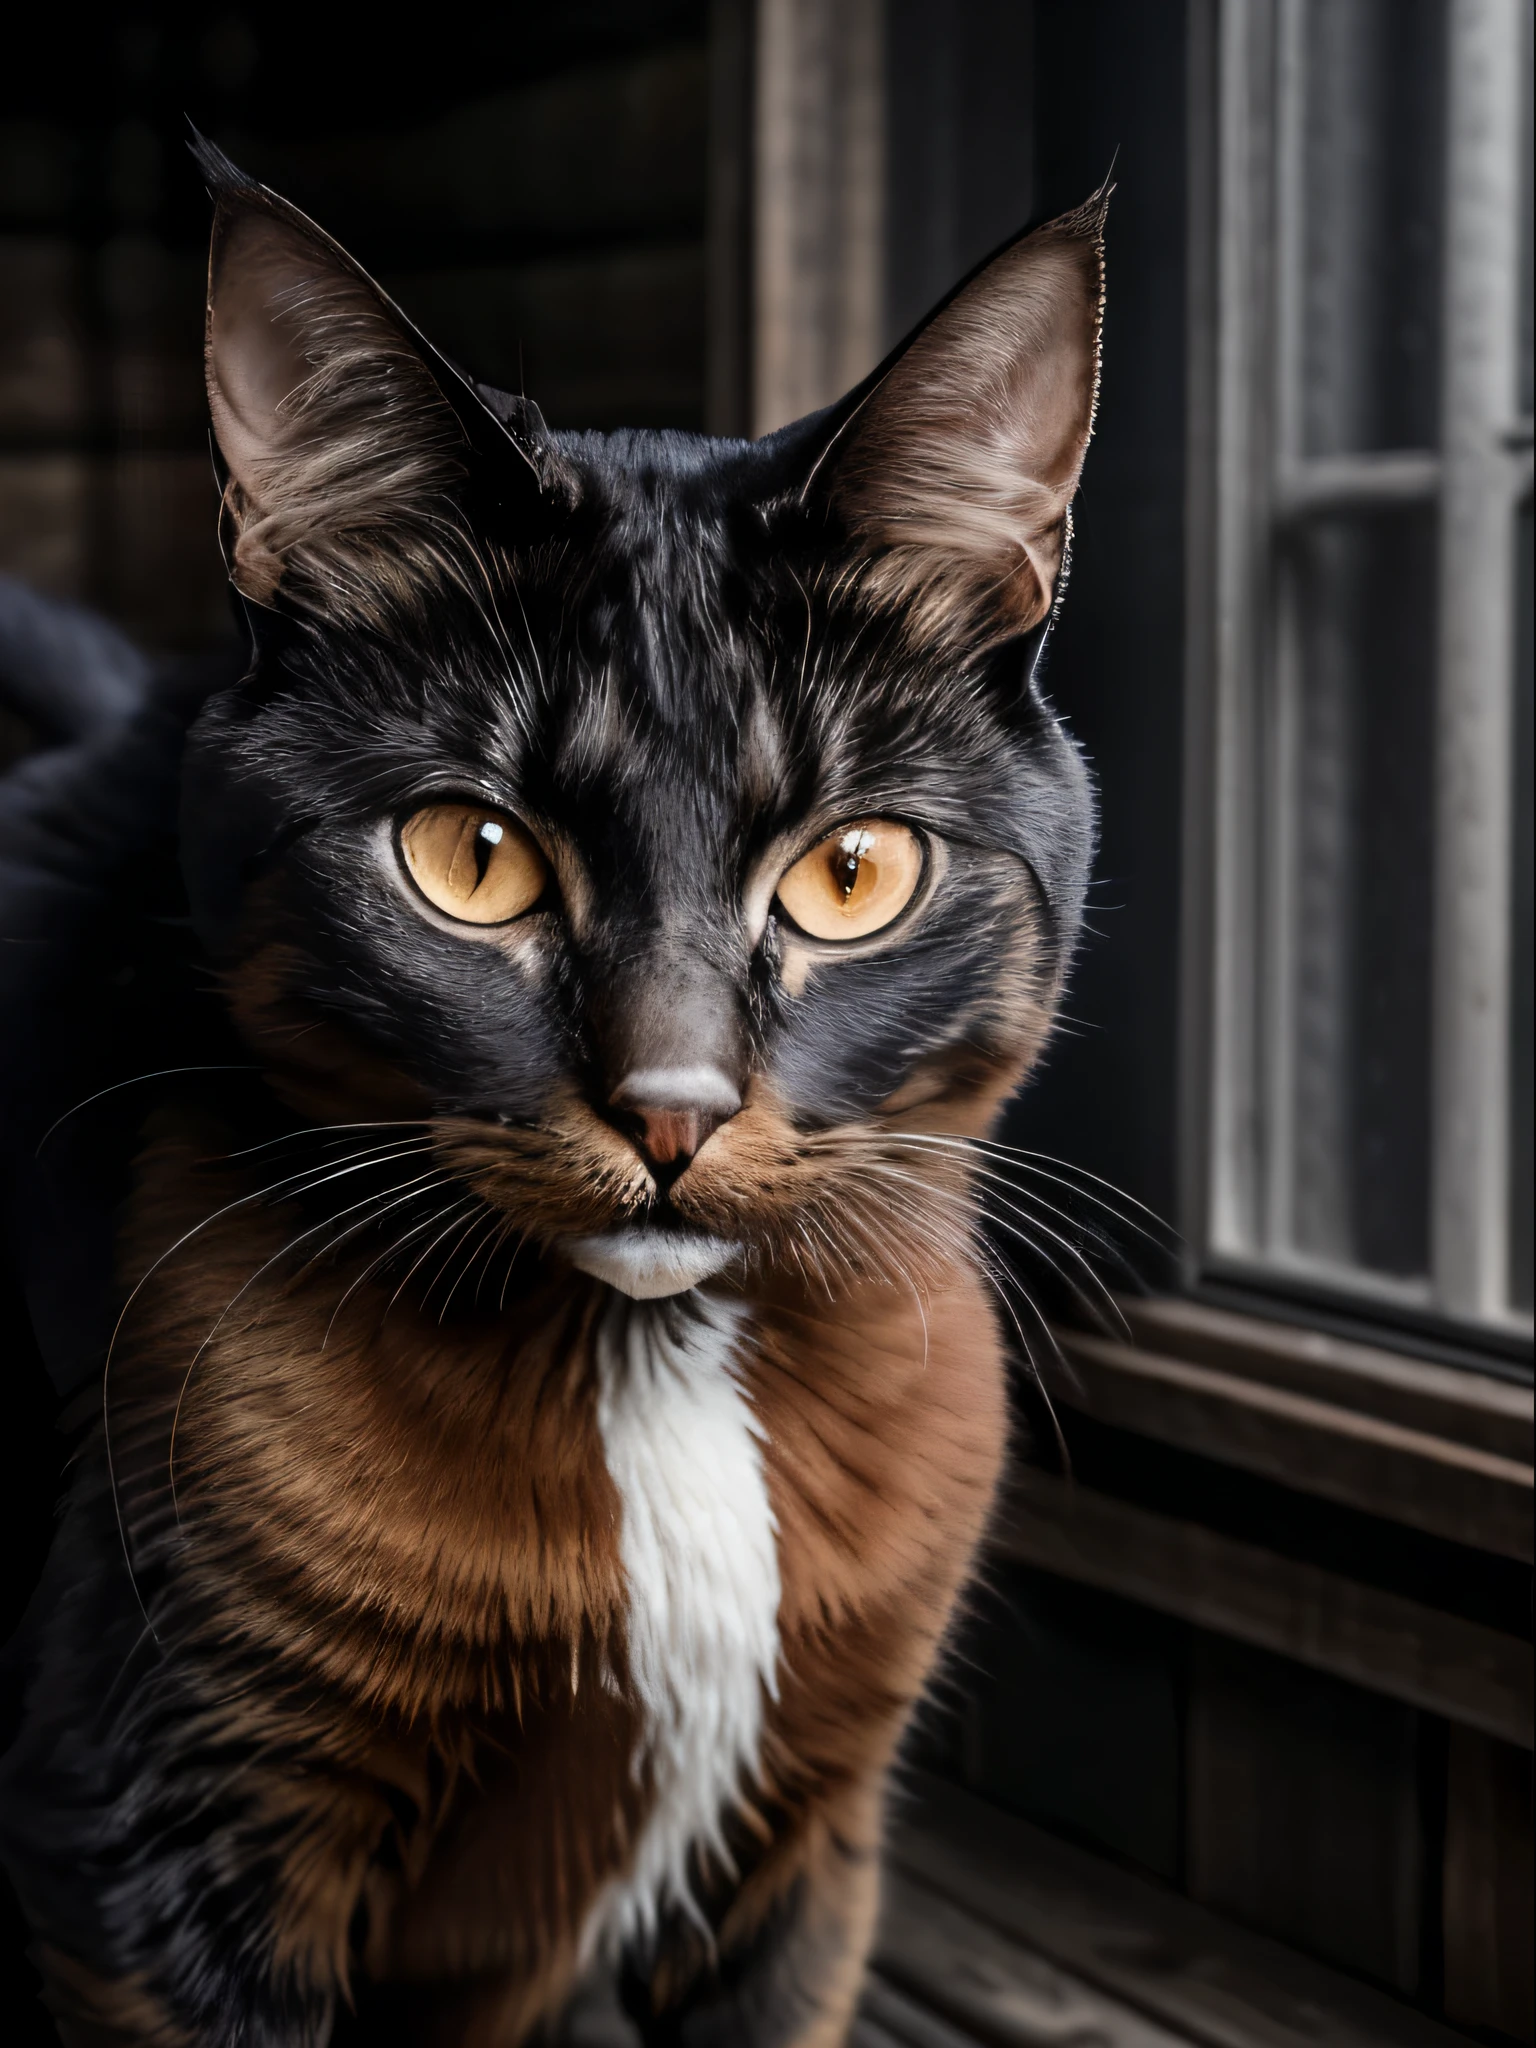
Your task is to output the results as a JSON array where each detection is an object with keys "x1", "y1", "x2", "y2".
[{"x1": 1300, "y1": 0, "x2": 1446, "y2": 455}]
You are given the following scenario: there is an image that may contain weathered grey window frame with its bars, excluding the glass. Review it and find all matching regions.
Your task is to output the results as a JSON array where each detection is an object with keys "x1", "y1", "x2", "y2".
[{"x1": 1180, "y1": 0, "x2": 1532, "y2": 1358}]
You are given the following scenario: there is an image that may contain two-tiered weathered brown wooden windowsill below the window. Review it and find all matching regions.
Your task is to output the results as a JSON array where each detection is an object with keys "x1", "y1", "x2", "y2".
[{"x1": 991, "y1": 1296, "x2": 1534, "y2": 1749}]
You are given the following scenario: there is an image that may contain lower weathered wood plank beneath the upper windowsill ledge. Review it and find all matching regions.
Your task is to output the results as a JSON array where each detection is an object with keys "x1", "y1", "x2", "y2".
[{"x1": 995, "y1": 1473, "x2": 1532, "y2": 1747}]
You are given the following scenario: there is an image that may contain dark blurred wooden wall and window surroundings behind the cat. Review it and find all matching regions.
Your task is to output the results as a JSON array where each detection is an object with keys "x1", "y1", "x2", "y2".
[{"x1": 0, "y1": 0, "x2": 1532, "y2": 2048}]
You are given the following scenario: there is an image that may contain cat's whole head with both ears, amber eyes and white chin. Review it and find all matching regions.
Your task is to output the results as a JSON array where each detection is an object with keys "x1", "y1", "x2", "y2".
[{"x1": 184, "y1": 152, "x2": 1104, "y2": 1294}]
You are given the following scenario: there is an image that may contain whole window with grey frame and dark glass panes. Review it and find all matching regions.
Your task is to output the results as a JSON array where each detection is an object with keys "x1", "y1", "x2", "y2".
[{"x1": 1190, "y1": 0, "x2": 1532, "y2": 1333}]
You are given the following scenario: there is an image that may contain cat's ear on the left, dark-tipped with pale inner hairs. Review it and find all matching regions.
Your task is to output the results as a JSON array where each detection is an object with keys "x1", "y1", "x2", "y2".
[{"x1": 195, "y1": 141, "x2": 561, "y2": 623}]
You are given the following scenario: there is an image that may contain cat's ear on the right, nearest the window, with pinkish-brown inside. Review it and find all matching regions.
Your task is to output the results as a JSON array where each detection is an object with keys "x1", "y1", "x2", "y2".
[{"x1": 827, "y1": 190, "x2": 1108, "y2": 641}]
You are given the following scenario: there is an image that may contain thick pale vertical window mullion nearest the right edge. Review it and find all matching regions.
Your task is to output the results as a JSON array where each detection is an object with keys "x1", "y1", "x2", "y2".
[{"x1": 1434, "y1": 0, "x2": 1522, "y2": 1317}]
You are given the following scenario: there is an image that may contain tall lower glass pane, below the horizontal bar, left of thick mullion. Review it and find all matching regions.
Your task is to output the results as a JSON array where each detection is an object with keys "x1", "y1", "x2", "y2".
[{"x1": 1290, "y1": 506, "x2": 1436, "y2": 1276}]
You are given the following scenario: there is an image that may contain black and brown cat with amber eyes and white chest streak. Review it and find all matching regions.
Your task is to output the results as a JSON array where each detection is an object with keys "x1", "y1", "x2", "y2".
[{"x1": 0, "y1": 145, "x2": 1106, "y2": 2048}]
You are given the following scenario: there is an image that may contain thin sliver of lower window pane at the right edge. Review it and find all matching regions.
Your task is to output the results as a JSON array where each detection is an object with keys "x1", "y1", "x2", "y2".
[{"x1": 1509, "y1": 504, "x2": 1536, "y2": 1309}]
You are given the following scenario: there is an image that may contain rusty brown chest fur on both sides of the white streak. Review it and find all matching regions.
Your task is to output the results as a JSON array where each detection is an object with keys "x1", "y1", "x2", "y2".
[{"x1": 109, "y1": 1137, "x2": 1006, "y2": 2038}]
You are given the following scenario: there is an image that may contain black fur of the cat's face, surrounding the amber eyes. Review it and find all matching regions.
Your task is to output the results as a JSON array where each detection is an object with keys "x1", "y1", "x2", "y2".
[{"x1": 184, "y1": 140, "x2": 1092, "y2": 1171}]
